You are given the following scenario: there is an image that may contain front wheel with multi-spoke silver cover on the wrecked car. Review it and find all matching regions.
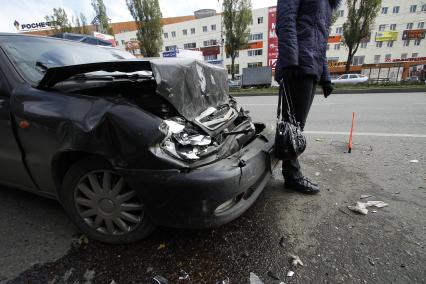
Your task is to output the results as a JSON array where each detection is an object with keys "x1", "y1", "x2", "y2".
[{"x1": 59, "y1": 158, "x2": 155, "y2": 244}]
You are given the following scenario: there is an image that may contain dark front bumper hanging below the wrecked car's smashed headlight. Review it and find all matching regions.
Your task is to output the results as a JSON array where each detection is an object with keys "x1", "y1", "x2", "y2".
[{"x1": 120, "y1": 130, "x2": 277, "y2": 228}]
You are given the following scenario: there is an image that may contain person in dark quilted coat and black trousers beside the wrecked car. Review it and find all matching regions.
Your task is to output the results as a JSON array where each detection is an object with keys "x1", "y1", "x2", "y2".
[{"x1": 275, "y1": 0, "x2": 340, "y2": 194}]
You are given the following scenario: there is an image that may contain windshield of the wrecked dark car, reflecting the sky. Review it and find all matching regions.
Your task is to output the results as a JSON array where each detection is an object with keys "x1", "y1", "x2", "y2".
[{"x1": 0, "y1": 36, "x2": 135, "y2": 85}]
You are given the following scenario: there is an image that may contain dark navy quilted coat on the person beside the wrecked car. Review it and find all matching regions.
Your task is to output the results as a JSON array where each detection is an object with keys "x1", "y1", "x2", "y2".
[{"x1": 275, "y1": 0, "x2": 341, "y2": 82}]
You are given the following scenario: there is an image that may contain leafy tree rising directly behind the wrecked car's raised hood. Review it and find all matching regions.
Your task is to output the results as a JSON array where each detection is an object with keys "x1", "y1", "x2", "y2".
[{"x1": 126, "y1": 0, "x2": 163, "y2": 57}]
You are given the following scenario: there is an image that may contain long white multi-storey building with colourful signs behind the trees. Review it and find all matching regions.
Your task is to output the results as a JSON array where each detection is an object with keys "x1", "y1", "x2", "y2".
[{"x1": 115, "y1": 0, "x2": 426, "y2": 77}]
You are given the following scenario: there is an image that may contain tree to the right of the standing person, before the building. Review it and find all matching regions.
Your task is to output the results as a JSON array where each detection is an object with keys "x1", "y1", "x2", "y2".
[{"x1": 343, "y1": 0, "x2": 382, "y2": 73}]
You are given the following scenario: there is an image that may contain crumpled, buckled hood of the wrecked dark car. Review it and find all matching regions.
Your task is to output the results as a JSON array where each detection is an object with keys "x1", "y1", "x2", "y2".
[{"x1": 37, "y1": 58, "x2": 229, "y2": 121}]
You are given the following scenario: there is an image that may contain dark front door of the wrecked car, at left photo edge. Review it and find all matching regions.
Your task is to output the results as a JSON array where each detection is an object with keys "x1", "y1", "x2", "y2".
[{"x1": 0, "y1": 72, "x2": 36, "y2": 190}]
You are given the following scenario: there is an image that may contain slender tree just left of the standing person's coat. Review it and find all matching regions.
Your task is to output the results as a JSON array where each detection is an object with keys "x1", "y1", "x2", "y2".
[{"x1": 223, "y1": 0, "x2": 252, "y2": 79}]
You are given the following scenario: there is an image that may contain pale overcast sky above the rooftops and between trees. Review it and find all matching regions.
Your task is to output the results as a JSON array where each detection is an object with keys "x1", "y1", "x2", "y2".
[{"x1": 0, "y1": 0, "x2": 277, "y2": 32}]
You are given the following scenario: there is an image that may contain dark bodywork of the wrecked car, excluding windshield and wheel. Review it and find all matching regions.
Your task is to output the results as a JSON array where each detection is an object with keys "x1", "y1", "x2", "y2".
[{"x1": 0, "y1": 35, "x2": 275, "y2": 227}]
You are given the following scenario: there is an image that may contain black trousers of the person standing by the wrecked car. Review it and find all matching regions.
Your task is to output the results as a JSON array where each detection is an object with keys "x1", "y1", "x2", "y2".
[{"x1": 282, "y1": 74, "x2": 317, "y2": 180}]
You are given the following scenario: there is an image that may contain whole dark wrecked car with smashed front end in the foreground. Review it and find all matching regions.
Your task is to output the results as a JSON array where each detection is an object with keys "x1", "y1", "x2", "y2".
[{"x1": 0, "y1": 34, "x2": 276, "y2": 243}]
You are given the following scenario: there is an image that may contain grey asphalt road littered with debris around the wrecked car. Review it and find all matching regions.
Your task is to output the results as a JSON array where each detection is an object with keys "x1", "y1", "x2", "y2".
[{"x1": 0, "y1": 93, "x2": 426, "y2": 283}]
